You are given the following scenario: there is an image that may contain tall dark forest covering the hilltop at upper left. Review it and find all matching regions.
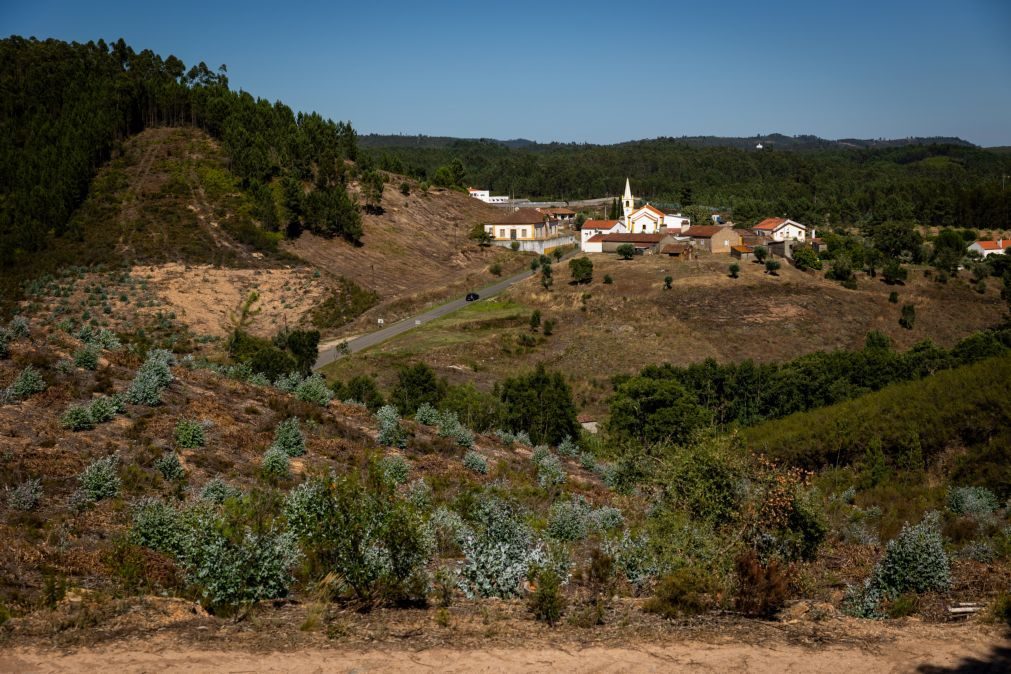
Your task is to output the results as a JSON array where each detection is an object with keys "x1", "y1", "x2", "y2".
[{"x1": 0, "y1": 36, "x2": 361, "y2": 267}]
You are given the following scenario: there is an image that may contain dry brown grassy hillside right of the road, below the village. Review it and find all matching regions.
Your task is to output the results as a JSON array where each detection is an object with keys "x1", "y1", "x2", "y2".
[{"x1": 328, "y1": 250, "x2": 1006, "y2": 410}]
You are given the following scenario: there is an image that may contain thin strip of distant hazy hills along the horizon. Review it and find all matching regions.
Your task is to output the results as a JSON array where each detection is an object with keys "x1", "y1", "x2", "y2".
[{"x1": 359, "y1": 133, "x2": 970, "y2": 151}]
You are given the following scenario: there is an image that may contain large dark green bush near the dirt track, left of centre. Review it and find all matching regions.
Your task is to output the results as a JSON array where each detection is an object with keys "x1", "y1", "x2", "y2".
[{"x1": 284, "y1": 474, "x2": 433, "y2": 601}]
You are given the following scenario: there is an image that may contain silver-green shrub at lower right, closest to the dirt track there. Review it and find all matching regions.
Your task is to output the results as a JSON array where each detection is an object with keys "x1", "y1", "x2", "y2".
[{"x1": 846, "y1": 512, "x2": 951, "y2": 617}]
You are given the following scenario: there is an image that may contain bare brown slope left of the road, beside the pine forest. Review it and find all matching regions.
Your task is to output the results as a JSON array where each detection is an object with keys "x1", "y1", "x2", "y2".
[{"x1": 283, "y1": 181, "x2": 529, "y2": 330}]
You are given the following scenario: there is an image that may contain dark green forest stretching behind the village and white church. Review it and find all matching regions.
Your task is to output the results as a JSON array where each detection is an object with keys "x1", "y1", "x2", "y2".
[{"x1": 363, "y1": 137, "x2": 1011, "y2": 228}]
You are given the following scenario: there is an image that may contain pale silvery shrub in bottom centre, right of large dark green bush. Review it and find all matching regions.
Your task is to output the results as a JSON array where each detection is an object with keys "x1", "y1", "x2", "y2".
[{"x1": 460, "y1": 498, "x2": 546, "y2": 598}]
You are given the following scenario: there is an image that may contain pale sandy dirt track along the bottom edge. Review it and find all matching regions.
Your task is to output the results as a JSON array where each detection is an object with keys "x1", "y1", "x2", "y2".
[{"x1": 0, "y1": 636, "x2": 1011, "y2": 674}]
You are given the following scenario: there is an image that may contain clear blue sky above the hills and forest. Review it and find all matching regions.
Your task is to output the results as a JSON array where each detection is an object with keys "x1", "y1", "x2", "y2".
[{"x1": 0, "y1": 0, "x2": 1011, "y2": 146}]
